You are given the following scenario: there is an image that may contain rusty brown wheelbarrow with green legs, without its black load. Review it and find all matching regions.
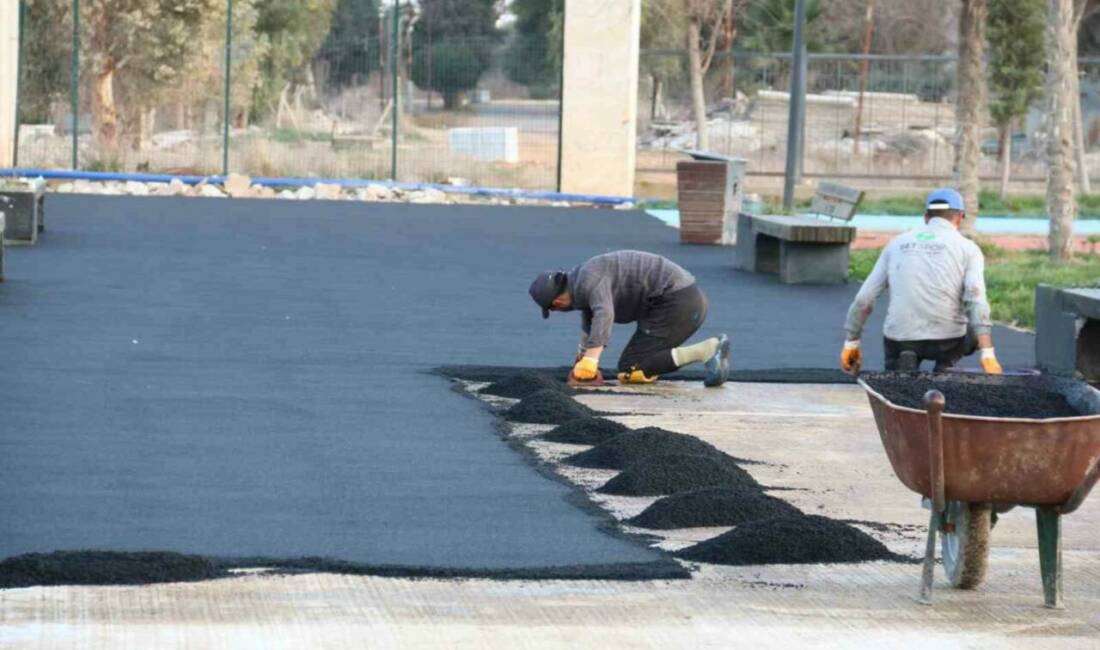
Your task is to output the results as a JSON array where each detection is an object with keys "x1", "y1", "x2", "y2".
[{"x1": 859, "y1": 375, "x2": 1100, "y2": 607}]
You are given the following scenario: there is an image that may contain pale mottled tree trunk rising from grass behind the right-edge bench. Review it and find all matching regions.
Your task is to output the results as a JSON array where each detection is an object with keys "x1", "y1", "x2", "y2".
[{"x1": 1046, "y1": 0, "x2": 1078, "y2": 263}]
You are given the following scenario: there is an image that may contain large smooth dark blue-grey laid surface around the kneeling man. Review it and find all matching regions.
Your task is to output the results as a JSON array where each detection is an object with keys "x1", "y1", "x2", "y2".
[{"x1": 0, "y1": 195, "x2": 1032, "y2": 575}]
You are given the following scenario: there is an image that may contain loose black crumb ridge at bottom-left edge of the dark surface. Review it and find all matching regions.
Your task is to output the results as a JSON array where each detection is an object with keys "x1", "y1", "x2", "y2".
[{"x1": 0, "y1": 551, "x2": 229, "y2": 588}]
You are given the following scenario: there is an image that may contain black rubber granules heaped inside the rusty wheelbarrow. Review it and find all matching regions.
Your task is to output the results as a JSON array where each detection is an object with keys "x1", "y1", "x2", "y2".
[{"x1": 865, "y1": 373, "x2": 1081, "y2": 418}]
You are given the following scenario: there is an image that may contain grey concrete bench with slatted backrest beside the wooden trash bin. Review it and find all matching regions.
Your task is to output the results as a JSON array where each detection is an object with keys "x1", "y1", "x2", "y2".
[{"x1": 735, "y1": 183, "x2": 864, "y2": 285}]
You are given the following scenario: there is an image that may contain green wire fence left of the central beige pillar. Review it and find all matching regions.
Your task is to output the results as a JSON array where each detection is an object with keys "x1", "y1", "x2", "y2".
[{"x1": 17, "y1": 0, "x2": 560, "y2": 189}]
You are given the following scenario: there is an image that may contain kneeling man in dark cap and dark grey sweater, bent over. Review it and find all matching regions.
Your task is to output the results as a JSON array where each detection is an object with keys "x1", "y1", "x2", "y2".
[{"x1": 530, "y1": 251, "x2": 729, "y2": 386}]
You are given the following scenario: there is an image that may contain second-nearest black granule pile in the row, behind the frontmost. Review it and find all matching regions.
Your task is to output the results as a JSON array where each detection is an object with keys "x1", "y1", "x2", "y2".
[{"x1": 627, "y1": 486, "x2": 801, "y2": 530}]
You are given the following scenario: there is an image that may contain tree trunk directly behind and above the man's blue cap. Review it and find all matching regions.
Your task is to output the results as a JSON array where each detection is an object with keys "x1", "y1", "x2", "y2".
[{"x1": 955, "y1": 0, "x2": 987, "y2": 236}]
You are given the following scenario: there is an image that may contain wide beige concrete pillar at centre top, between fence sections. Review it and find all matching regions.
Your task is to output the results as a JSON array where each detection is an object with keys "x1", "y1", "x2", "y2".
[{"x1": 561, "y1": 0, "x2": 641, "y2": 196}]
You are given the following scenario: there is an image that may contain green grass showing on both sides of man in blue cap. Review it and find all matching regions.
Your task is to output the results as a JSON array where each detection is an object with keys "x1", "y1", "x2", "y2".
[{"x1": 848, "y1": 244, "x2": 1100, "y2": 329}]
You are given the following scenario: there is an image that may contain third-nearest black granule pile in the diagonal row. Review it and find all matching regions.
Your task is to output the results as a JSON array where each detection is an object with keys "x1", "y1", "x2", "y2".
[{"x1": 596, "y1": 454, "x2": 759, "y2": 496}]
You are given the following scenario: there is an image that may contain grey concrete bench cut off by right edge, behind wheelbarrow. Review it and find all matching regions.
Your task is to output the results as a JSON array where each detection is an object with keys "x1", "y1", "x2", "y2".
[{"x1": 1035, "y1": 285, "x2": 1100, "y2": 384}]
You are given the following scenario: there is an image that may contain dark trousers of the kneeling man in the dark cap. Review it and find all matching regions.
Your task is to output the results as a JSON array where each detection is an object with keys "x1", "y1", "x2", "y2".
[{"x1": 619, "y1": 285, "x2": 706, "y2": 377}]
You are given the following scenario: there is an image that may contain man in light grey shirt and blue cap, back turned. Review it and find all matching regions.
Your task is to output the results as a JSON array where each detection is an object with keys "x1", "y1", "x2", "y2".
[{"x1": 840, "y1": 188, "x2": 1001, "y2": 374}]
